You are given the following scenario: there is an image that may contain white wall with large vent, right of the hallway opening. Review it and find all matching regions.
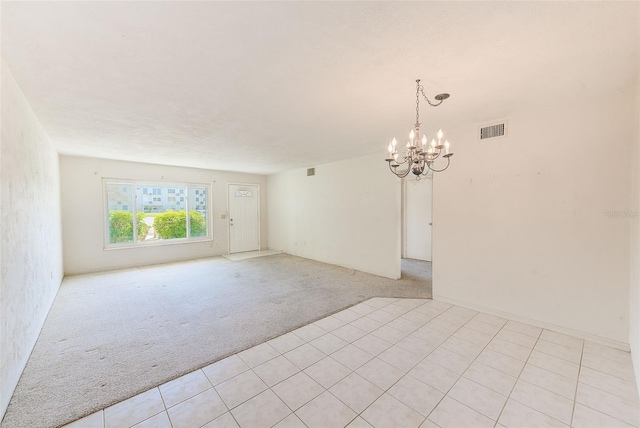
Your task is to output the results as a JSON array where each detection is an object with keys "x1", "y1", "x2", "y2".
[{"x1": 433, "y1": 89, "x2": 637, "y2": 344}]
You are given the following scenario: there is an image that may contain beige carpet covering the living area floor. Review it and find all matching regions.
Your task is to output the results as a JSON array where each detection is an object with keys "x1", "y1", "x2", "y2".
[{"x1": 2, "y1": 254, "x2": 431, "y2": 428}]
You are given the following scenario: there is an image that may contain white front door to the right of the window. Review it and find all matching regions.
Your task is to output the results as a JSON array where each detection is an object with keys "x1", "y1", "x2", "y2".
[{"x1": 229, "y1": 184, "x2": 260, "y2": 253}]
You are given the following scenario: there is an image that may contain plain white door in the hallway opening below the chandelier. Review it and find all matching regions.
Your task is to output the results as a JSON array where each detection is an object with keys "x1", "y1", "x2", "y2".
[{"x1": 403, "y1": 178, "x2": 433, "y2": 261}]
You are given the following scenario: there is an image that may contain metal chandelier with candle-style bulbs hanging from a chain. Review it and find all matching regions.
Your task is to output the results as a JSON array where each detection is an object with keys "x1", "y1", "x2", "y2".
[{"x1": 385, "y1": 79, "x2": 453, "y2": 180}]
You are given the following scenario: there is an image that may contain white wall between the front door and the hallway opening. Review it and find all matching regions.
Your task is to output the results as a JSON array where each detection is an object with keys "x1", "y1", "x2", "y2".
[{"x1": 268, "y1": 152, "x2": 400, "y2": 279}]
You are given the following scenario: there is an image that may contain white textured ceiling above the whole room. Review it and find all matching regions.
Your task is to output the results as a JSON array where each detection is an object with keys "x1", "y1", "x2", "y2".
[{"x1": 0, "y1": 1, "x2": 640, "y2": 174}]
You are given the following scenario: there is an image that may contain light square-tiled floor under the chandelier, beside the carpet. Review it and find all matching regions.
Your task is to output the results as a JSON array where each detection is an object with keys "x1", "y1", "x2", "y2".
[{"x1": 61, "y1": 298, "x2": 640, "y2": 428}]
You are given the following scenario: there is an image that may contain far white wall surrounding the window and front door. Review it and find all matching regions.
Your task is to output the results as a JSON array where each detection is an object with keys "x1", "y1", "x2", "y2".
[{"x1": 60, "y1": 156, "x2": 268, "y2": 274}]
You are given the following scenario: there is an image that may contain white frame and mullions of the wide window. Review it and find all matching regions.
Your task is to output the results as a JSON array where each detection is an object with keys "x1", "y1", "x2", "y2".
[{"x1": 102, "y1": 177, "x2": 213, "y2": 250}]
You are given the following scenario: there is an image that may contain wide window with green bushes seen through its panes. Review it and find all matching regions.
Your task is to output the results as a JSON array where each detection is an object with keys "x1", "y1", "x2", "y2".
[{"x1": 104, "y1": 179, "x2": 211, "y2": 247}]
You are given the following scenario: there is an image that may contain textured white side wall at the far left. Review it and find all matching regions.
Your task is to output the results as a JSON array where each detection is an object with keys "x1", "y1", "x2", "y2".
[{"x1": 0, "y1": 61, "x2": 62, "y2": 420}]
